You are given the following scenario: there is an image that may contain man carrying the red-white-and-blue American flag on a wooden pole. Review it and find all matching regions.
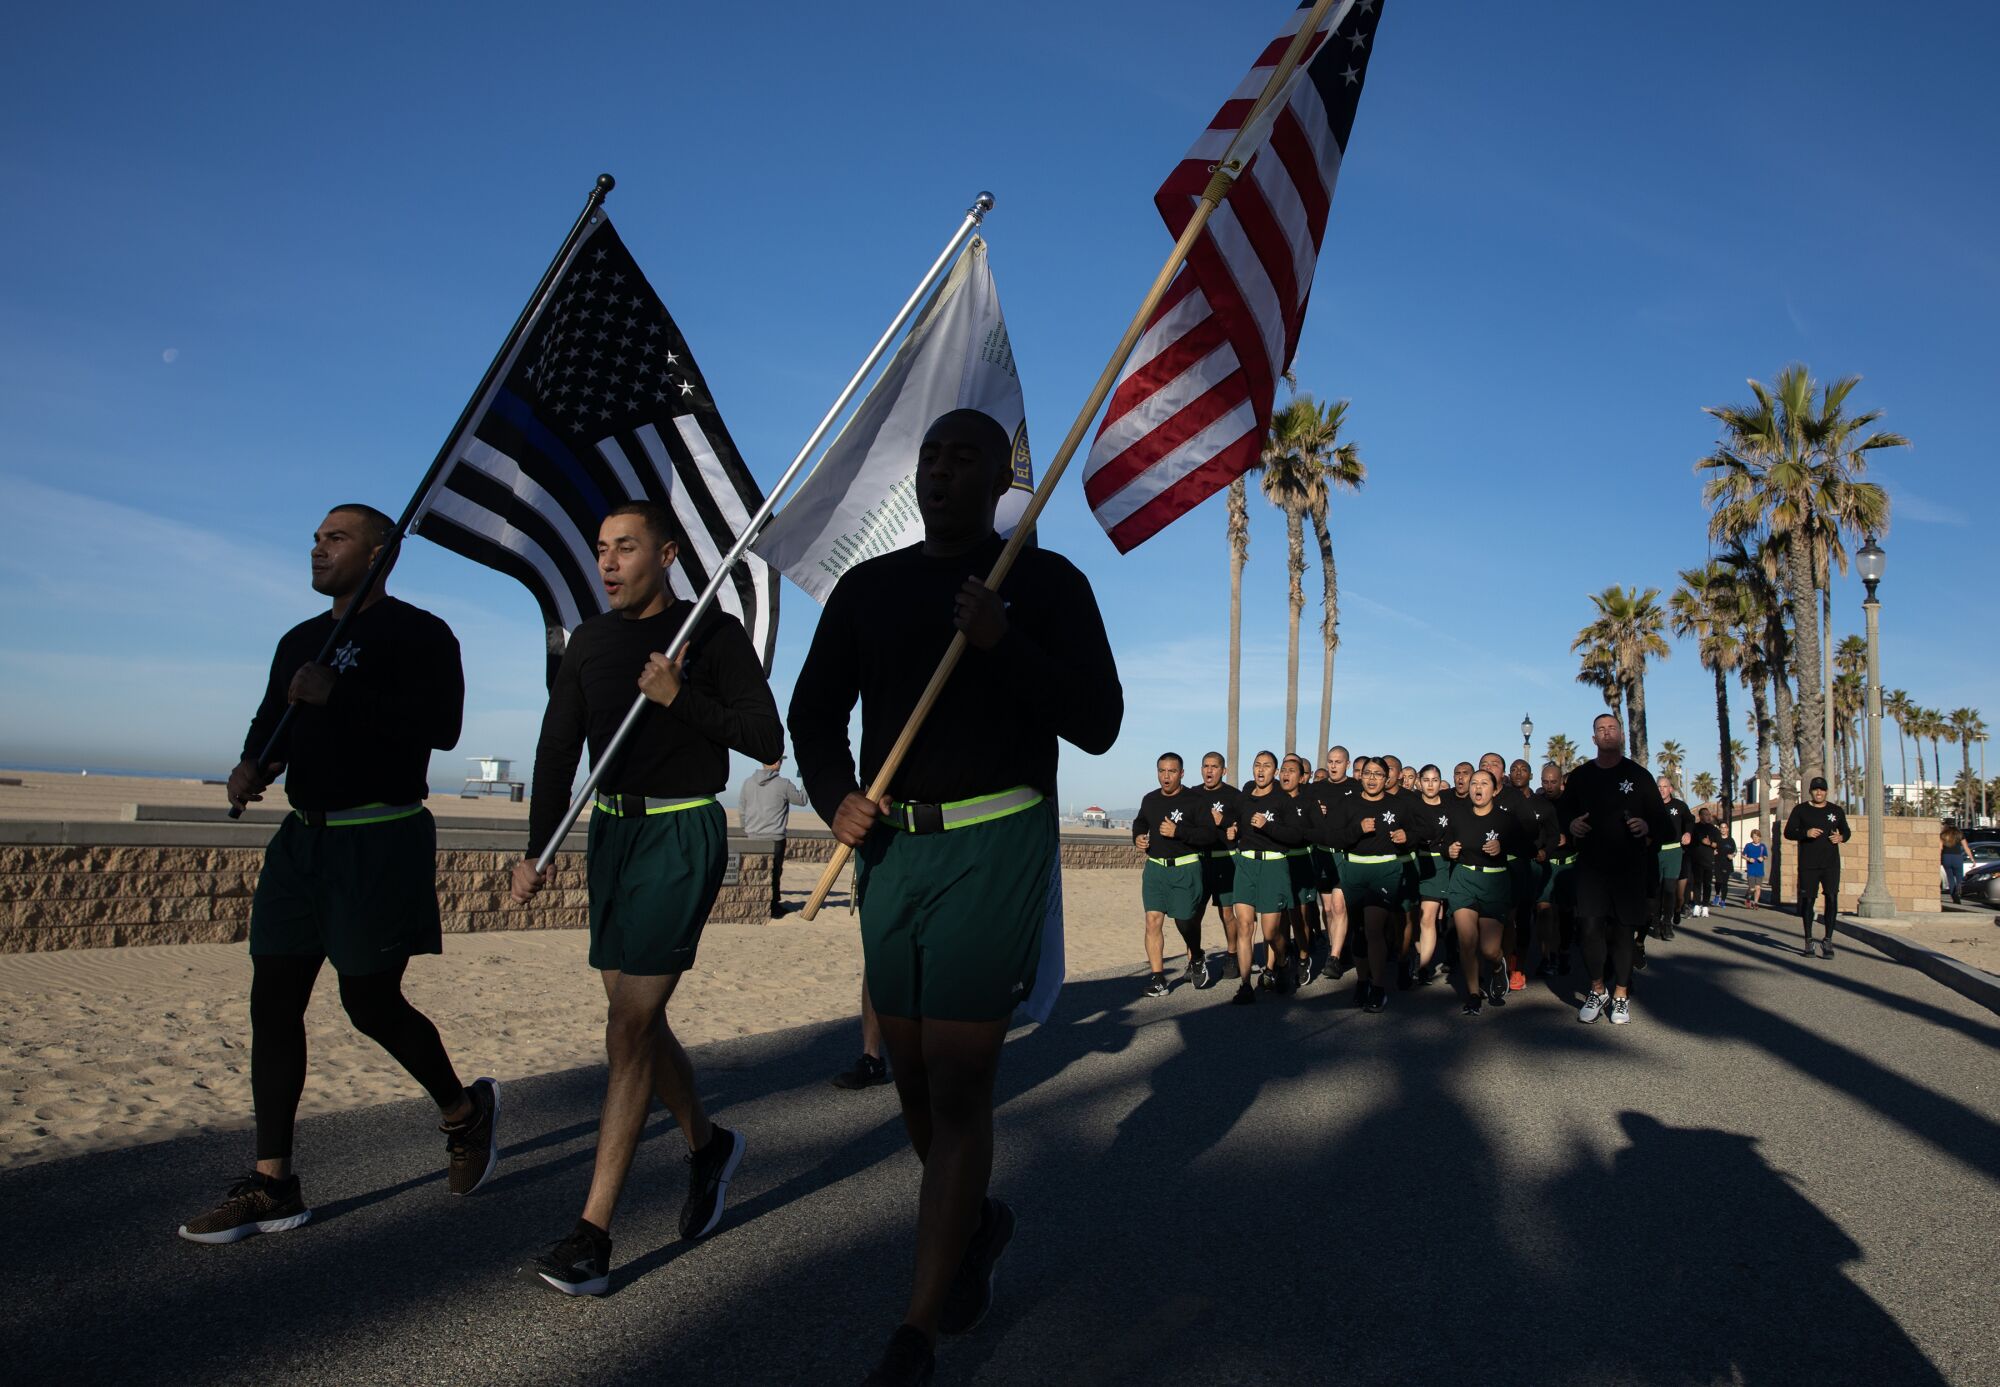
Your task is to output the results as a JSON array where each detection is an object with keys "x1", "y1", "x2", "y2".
[{"x1": 788, "y1": 410, "x2": 1124, "y2": 1387}]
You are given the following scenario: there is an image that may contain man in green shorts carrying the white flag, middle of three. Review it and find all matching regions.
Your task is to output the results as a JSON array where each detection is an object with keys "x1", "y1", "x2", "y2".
[{"x1": 512, "y1": 502, "x2": 784, "y2": 1295}]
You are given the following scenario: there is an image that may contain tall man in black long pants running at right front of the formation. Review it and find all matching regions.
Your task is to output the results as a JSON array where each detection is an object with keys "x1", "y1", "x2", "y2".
[{"x1": 1560, "y1": 713, "x2": 1668, "y2": 1025}]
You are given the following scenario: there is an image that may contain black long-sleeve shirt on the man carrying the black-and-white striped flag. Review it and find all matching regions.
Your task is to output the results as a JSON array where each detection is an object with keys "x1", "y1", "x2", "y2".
[{"x1": 244, "y1": 598, "x2": 466, "y2": 809}]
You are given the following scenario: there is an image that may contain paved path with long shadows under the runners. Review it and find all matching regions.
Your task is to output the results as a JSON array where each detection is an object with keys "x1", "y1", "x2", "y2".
[{"x1": 0, "y1": 911, "x2": 2000, "y2": 1387}]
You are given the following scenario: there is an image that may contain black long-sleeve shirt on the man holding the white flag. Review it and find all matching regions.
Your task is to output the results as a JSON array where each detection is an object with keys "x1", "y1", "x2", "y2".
[{"x1": 528, "y1": 602, "x2": 784, "y2": 851}]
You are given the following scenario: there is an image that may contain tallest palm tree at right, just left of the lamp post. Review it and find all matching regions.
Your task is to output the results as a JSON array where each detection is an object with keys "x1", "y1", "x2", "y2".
[{"x1": 1694, "y1": 364, "x2": 1908, "y2": 799}]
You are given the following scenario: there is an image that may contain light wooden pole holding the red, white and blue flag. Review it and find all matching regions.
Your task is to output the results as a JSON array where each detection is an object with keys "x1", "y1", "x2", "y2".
[{"x1": 800, "y1": 0, "x2": 1354, "y2": 919}]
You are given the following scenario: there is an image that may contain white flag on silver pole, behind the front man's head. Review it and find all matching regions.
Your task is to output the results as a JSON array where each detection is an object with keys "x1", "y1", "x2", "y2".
[{"x1": 750, "y1": 236, "x2": 1034, "y2": 604}]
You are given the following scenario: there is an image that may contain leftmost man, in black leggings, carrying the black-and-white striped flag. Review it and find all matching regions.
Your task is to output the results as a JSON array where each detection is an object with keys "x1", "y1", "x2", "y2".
[{"x1": 180, "y1": 506, "x2": 500, "y2": 1243}]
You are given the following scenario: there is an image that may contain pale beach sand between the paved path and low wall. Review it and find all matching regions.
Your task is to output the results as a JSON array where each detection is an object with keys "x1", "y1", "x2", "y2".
[{"x1": 0, "y1": 869, "x2": 1160, "y2": 1169}]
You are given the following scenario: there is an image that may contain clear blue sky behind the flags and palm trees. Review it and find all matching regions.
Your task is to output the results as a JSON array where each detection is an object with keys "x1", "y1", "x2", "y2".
[{"x1": 0, "y1": 0, "x2": 2000, "y2": 805}]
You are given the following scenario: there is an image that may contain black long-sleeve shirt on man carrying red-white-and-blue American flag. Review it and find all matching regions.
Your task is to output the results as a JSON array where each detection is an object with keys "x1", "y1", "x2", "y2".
[{"x1": 786, "y1": 536, "x2": 1124, "y2": 823}]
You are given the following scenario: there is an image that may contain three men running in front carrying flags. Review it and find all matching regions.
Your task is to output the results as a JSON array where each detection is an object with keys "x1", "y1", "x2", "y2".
[{"x1": 180, "y1": 410, "x2": 1124, "y2": 1387}]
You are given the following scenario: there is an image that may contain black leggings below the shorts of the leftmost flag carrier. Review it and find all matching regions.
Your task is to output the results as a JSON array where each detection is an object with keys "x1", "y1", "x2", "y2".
[{"x1": 250, "y1": 953, "x2": 466, "y2": 1161}]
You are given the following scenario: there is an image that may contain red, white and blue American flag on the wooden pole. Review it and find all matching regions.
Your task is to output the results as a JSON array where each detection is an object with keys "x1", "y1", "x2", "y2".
[{"x1": 1084, "y1": 0, "x2": 1382, "y2": 552}]
